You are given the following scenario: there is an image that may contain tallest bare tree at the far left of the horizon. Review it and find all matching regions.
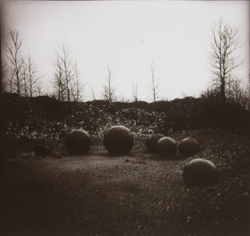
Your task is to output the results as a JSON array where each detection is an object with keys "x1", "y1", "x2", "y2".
[{"x1": 5, "y1": 30, "x2": 24, "y2": 95}]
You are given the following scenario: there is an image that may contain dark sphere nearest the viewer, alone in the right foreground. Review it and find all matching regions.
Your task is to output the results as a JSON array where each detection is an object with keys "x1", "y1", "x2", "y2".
[{"x1": 182, "y1": 158, "x2": 219, "y2": 188}]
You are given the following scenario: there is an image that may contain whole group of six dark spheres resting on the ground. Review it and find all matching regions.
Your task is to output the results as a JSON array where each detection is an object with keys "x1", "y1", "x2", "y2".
[{"x1": 65, "y1": 125, "x2": 219, "y2": 188}]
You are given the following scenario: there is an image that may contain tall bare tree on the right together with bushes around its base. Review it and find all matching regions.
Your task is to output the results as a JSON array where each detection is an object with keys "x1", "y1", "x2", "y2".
[{"x1": 202, "y1": 19, "x2": 250, "y2": 108}]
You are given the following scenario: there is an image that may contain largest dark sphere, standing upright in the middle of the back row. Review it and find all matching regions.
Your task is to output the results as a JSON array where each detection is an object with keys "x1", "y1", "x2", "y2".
[{"x1": 103, "y1": 125, "x2": 134, "y2": 156}]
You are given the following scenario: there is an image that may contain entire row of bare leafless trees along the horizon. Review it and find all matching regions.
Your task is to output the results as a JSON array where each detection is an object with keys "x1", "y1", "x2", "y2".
[{"x1": 1, "y1": 19, "x2": 250, "y2": 108}]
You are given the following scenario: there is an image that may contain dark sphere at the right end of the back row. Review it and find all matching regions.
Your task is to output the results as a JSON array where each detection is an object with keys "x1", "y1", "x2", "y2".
[{"x1": 179, "y1": 138, "x2": 200, "y2": 157}]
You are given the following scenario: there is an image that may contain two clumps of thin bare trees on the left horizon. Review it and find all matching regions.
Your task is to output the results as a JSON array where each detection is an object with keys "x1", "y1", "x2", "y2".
[{"x1": 1, "y1": 30, "x2": 83, "y2": 102}]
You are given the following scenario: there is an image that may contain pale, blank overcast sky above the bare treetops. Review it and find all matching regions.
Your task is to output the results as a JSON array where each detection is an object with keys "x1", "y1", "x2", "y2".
[{"x1": 1, "y1": 1, "x2": 250, "y2": 102}]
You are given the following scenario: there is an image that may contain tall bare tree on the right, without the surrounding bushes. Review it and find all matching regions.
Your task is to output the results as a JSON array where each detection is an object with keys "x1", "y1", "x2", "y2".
[{"x1": 209, "y1": 19, "x2": 243, "y2": 102}]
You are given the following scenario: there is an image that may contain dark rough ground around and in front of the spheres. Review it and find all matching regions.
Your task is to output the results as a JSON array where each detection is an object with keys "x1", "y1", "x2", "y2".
[{"x1": 0, "y1": 130, "x2": 250, "y2": 236}]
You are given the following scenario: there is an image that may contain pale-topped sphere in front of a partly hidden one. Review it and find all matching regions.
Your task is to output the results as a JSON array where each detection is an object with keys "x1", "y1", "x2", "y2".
[{"x1": 157, "y1": 137, "x2": 177, "y2": 158}]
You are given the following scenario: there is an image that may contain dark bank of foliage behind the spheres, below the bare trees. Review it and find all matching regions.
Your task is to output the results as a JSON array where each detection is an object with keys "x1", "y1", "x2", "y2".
[{"x1": 2, "y1": 93, "x2": 250, "y2": 150}]
